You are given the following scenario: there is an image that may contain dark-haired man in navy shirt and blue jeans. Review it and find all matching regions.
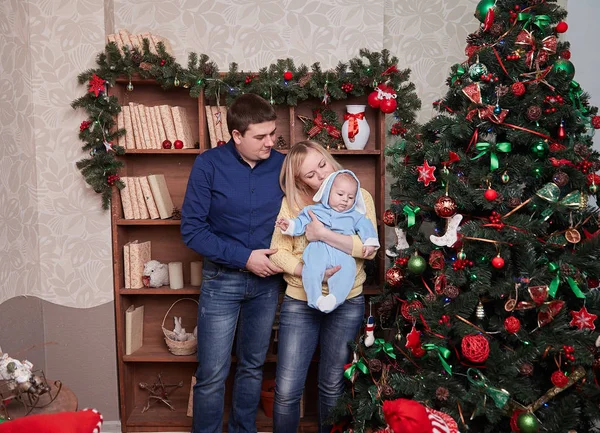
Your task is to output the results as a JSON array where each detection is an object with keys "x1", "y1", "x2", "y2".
[{"x1": 181, "y1": 94, "x2": 284, "y2": 433}]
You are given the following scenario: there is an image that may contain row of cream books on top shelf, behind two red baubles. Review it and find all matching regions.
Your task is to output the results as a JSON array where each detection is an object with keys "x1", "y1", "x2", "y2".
[{"x1": 117, "y1": 102, "x2": 195, "y2": 149}]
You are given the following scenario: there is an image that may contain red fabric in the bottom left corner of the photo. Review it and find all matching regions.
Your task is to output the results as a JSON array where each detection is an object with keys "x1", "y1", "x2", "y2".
[{"x1": 0, "y1": 409, "x2": 102, "y2": 433}]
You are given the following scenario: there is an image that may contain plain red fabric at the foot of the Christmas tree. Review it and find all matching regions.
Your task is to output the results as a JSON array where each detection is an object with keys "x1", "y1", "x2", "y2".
[{"x1": 383, "y1": 398, "x2": 432, "y2": 433}]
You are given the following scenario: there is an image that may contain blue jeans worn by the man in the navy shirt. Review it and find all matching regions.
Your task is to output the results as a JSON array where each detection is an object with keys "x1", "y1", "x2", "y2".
[{"x1": 192, "y1": 260, "x2": 282, "y2": 433}]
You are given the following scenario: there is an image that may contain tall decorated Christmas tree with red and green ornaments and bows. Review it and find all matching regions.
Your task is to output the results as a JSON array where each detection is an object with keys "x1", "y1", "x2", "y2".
[{"x1": 334, "y1": 0, "x2": 600, "y2": 433}]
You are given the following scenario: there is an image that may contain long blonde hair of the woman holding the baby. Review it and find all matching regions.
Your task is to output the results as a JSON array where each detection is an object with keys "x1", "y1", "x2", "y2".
[{"x1": 279, "y1": 140, "x2": 342, "y2": 211}]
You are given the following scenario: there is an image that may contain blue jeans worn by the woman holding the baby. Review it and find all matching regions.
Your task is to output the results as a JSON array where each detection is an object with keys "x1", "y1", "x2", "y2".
[{"x1": 273, "y1": 295, "x2": 365, "y2": 433}]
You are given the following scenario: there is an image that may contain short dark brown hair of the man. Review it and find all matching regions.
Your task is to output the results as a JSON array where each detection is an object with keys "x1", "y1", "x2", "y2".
[{"x1": 227, "y1": 93, "x2": 277, "y2": 135}]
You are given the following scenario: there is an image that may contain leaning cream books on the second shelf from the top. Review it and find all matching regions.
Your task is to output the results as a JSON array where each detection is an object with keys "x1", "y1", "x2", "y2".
[{"x1": 120, "y1": 174, "x2": 173, "y2": 220}]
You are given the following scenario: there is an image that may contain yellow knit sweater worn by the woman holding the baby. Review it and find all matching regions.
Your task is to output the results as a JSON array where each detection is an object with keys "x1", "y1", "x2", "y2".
[{"x1": 271, "y1": 188, "x2": 377, "y2": 301}]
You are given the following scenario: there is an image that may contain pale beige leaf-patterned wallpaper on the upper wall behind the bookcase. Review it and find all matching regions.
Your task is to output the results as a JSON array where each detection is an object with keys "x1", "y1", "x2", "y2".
[{"x1": 0, "y1": 0, "x2": 572, "y2": 308}]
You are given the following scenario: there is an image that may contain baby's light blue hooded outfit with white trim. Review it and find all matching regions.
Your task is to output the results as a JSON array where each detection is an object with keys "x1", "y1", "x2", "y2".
[{"x1": 283, "y1": 170, "x2": 379, "y2": 313}]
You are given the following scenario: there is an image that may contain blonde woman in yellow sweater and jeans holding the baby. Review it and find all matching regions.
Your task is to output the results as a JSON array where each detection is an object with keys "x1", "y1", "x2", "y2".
[{"x1": 270, "y1": 141, "x2": 377, "y2": 433}]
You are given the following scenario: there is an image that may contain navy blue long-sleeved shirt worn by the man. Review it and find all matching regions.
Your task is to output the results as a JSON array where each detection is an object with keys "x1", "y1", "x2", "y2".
[{"x1": 181, "y1": 140, "x2": 284, "y2": 268}]
